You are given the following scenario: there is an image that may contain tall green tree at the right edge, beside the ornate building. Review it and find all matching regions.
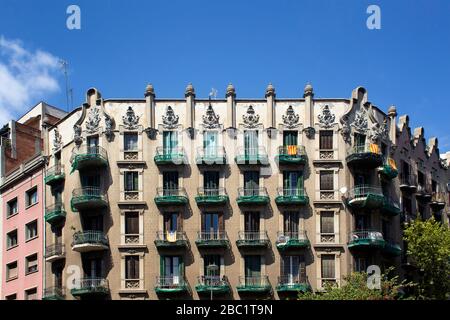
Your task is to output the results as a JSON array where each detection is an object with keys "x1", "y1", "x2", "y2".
[{"x1": 404, "y1": 218, "x2": 450, "y2": 299}]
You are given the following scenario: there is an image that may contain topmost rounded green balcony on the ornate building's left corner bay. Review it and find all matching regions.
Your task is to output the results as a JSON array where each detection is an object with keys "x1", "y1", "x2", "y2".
[{"x1": 70, "y1": 146, "x2": 108, "y2": 172}]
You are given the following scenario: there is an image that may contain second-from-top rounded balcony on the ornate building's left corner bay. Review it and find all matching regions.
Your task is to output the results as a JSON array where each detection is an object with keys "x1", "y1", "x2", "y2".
[{"x1": 70, "y1": 187, "x2": 108, "y2": 212}]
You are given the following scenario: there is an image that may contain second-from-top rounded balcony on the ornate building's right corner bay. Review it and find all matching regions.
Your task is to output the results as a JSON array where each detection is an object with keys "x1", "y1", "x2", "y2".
[{"x1": 347, "y1": 185, "x2": 385, "y2": 209}]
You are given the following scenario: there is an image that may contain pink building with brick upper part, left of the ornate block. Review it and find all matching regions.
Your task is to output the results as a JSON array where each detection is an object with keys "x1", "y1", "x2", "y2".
[{"x1": 0, "y1": 103, "x2": 66, "y2": 300}]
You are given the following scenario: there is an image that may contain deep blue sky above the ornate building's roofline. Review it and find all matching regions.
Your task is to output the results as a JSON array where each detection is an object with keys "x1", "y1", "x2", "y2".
[{"x1": 0, "y1": 0, "x2": 450, "y2": 152}]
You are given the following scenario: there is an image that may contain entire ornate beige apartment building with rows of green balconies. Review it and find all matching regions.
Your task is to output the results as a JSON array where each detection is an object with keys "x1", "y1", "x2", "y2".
[{"x1": 38, "y1": 85, "x2": 449, "y2": 299}]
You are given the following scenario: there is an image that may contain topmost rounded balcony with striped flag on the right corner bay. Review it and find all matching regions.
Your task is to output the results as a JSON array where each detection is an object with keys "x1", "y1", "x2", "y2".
[{"x1": 346, "y1": 143, "x2": 383, "y2": 169}]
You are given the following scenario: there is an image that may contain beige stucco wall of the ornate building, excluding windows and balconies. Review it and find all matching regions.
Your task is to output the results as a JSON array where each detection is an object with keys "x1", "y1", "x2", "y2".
[{"x1": 44, "y1": 85, "x2": 450, "y2": 299}]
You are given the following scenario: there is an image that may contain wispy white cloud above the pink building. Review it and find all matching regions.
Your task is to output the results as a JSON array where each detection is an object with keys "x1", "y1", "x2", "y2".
[{"x1": 0, "y1": 36, "x2": 61, "y2": 126}]
